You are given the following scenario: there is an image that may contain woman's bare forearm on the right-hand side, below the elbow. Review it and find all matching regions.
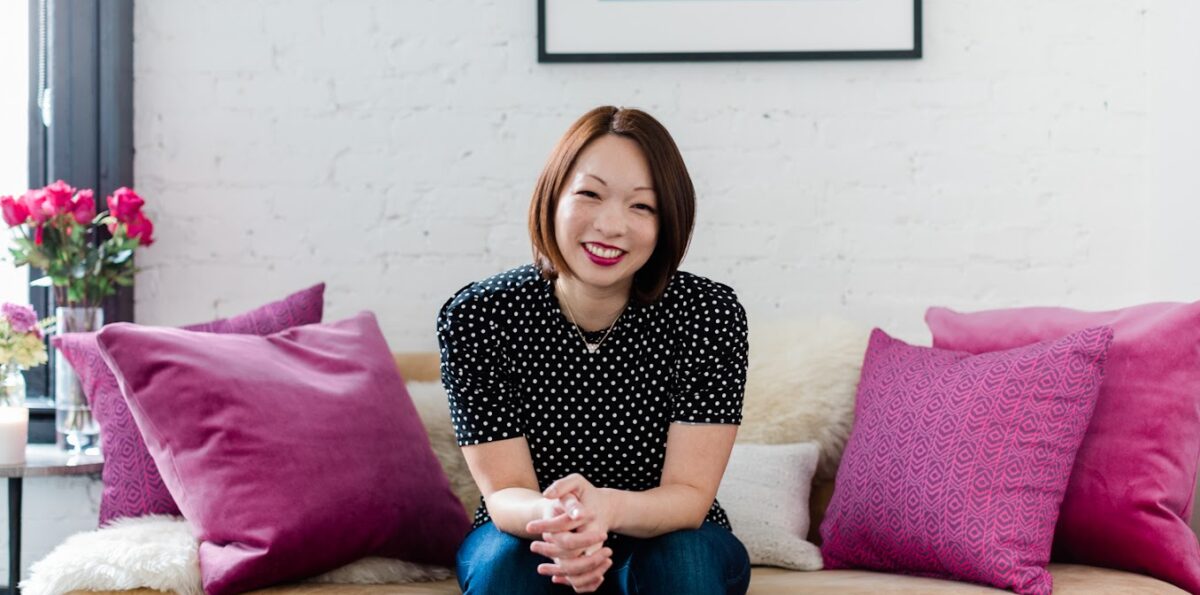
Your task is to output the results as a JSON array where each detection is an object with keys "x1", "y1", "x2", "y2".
[{"x1": 601, "y1": 483, "x2": 713, "y2": 539}]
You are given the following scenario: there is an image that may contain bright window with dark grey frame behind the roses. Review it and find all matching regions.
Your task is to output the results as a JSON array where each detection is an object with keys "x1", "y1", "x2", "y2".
[{"x1": 0, "y1": 0, "x2": 133, "y2": 441}]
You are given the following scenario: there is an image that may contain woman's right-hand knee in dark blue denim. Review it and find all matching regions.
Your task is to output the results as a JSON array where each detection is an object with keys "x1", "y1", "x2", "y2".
[{"x1": 620, "y1": 522, "x2": 750, "y2": 595}]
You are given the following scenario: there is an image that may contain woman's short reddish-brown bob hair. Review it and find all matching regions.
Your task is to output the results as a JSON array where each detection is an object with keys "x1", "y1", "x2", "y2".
[{"x1": 529, "y1": 106, "x2": 696, "y2": 305}]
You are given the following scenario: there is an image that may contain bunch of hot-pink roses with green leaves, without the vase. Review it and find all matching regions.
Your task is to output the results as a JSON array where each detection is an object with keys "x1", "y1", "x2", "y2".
[{"x1": 0, "y1": 180, "x2": 154, "y2": 306}]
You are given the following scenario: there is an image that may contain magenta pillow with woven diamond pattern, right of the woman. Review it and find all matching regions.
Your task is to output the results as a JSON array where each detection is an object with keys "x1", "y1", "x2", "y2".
[{"x1": 821, "y1": 326, "x2": 1112, "y2": 595}]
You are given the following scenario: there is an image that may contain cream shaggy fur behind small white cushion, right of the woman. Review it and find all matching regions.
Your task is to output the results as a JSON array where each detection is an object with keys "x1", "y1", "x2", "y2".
[{"x1": 738, "y1": 317, "x2": 870, "y2": 482}]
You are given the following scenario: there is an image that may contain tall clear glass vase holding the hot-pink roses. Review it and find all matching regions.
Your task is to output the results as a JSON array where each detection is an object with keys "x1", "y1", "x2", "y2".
[{"x1": 54, "y1": 306, "x2": 104, "y2": 455}]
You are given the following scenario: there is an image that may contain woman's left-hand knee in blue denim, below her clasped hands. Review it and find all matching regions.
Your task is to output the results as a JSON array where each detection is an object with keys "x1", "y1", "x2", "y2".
[{"x1": 456, "y1": 523, "x2": 570, "y2": 595}]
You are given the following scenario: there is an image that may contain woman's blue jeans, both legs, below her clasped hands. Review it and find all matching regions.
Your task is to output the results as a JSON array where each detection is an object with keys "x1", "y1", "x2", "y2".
[{"x1": 457, "y1": 521, "x2": 750, "y2": 595}]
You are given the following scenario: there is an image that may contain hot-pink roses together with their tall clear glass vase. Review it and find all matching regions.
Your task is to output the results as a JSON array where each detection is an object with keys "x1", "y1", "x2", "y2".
[{"x1": 0, "y1": 180, "x2": 154, "y2": 451}]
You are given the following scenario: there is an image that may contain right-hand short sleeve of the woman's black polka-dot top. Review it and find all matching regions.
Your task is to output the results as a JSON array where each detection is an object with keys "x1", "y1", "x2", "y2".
[{"x1": 671, "y1": 282, "x2": 749, "y2": 423}]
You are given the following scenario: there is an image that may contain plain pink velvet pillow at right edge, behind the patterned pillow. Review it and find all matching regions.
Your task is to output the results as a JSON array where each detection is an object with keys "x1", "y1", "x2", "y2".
[{"x1": 925, "y1": 302, "x2": 1200, "y2": 593}]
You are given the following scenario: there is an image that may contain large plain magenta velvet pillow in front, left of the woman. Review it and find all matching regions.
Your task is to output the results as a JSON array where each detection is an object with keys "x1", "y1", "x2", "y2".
[{"x1": 98, "y1": 312, "x2": 468, "y2": 595}]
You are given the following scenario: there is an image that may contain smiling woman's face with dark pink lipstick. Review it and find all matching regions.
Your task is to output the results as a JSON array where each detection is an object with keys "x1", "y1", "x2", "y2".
[{"x1": 554, "y1": 134, "x2": 659, "y2": 289}]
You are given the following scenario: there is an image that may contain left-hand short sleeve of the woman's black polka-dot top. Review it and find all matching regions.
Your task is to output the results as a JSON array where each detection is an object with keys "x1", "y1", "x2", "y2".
[{"x1": 437, "y1": 284, "x2": 523, "y2": 446}]
